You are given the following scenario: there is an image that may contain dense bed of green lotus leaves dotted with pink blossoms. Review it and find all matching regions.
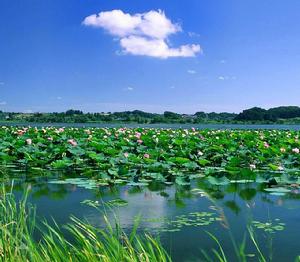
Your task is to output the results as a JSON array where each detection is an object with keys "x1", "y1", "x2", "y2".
[{"x1": 0, "y1": 127, "x2": 300, "y2": 187}]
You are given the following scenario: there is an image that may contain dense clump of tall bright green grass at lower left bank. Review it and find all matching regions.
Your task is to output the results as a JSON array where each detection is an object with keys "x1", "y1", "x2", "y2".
[{"x1": 0, "y1": 187, "x2": 171, "y2": 262}]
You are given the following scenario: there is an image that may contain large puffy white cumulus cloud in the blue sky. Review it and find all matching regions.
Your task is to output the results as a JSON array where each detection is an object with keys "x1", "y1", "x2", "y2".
[{"x1": 83, "y1": 10, "x2": 201, "y2": 58}]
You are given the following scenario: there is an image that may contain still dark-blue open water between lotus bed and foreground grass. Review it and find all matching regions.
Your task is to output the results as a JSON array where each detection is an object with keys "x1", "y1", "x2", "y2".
[{"x1": 8, "y1": 173, "x2": 300, "y2": 262}]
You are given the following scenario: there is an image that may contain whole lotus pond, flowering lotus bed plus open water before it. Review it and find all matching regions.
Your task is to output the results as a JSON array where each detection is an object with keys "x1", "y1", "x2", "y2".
[{"x1": 0, "y1": 127, "x2": 300, "y2": 261}]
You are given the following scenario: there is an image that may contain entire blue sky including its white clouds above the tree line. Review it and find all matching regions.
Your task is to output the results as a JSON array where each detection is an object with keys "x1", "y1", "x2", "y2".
[{"x1": 0, "y1": 0, "x2": 300, "y2": 113}]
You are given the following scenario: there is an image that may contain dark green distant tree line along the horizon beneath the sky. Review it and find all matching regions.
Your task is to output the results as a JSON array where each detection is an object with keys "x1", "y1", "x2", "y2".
[{"x1": 0, "y1": 106, "x2": 300, "y2": 124}]
